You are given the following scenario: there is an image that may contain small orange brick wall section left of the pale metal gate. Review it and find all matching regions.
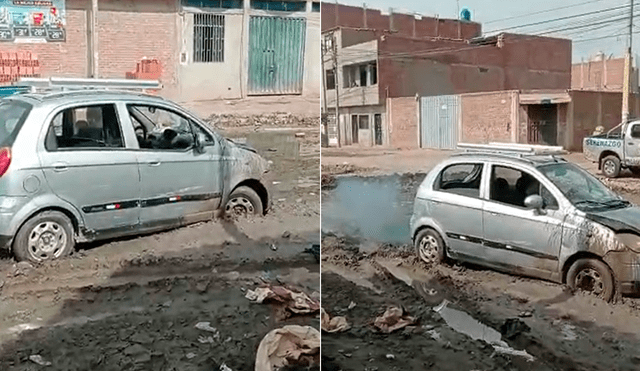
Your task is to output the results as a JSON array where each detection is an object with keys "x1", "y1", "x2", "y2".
[{"x1": 387, "y1": 97, "x2": 420, "y2": 149}]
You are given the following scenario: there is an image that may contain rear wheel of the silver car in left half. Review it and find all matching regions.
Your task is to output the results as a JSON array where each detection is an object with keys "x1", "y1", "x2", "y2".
[{"x1": 13, "y1": 211, "x2": 75, "y2": 263}]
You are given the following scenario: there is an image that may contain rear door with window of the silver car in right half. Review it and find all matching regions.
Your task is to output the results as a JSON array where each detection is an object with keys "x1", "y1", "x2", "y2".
[{"x1": 430, "y1": 162, "x2": 484, "y2": 259}]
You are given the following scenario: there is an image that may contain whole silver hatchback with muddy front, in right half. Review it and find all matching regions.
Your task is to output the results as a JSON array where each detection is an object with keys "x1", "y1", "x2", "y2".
[{"x1": 410, "y1": 148, "x2": 640, "y2": 300}]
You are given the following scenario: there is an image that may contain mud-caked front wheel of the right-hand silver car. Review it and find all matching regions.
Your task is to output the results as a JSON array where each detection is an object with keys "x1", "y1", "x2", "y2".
[{"x1": 567, "y1": 259, "x2": 615, "y2": 301}]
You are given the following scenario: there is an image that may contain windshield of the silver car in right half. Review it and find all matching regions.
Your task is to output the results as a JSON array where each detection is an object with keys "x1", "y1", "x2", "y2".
[{"x1": 538, "y1": 163, "x2": 630, "y2": 211}]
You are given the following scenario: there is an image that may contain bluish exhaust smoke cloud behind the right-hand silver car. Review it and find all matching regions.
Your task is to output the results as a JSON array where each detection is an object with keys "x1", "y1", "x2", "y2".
[{"x1": 322, "y1": 174, "x2": 423, "y2": 243}]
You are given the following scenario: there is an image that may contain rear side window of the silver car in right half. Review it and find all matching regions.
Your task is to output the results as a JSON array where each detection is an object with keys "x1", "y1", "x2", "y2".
[{"x1": 435, "y1": 163, "x2": 482, "y2": 198}]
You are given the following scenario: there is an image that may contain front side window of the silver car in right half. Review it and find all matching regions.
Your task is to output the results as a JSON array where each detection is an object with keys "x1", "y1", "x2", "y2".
[{"x1": 489, "y1": 166, "x2": 558, "y2": 209}]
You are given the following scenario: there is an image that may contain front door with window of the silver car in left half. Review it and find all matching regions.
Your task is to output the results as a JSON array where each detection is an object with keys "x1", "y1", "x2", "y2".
[{"x1": 127, "y1": 103, "x2": 222, "y2": 229}]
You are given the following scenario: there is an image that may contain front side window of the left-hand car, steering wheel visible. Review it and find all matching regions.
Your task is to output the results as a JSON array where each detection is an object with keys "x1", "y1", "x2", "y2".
[{"x1": 127, "y1": 104, "x2": 195, "y2": 151}]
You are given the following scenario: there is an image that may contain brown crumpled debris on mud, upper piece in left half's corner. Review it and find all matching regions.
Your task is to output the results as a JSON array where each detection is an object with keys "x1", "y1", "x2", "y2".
[{"x1": 245, "y1": 286, "x2": 320, "y2": 314}]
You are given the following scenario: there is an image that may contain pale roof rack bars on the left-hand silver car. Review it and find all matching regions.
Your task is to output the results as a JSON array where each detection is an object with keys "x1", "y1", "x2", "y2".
[{"x1": 13, "y1": 77, "x2": 162, "y2": 93}]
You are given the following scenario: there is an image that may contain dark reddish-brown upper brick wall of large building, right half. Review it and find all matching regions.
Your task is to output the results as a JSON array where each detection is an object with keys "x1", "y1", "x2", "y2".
[{"x1": 378, "y1": 35, "x2": 571, "y2": 97}]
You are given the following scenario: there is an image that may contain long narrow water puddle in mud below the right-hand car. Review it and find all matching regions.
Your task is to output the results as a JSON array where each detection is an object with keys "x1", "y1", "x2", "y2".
[{"x1": 433, "y1": 299, "x2": 534, "y2": 362}]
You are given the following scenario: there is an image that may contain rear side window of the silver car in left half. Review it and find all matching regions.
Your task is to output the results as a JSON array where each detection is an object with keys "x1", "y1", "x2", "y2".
[{"x1": 45, "y1": 104, "x2": 124, "y2": 151}]
